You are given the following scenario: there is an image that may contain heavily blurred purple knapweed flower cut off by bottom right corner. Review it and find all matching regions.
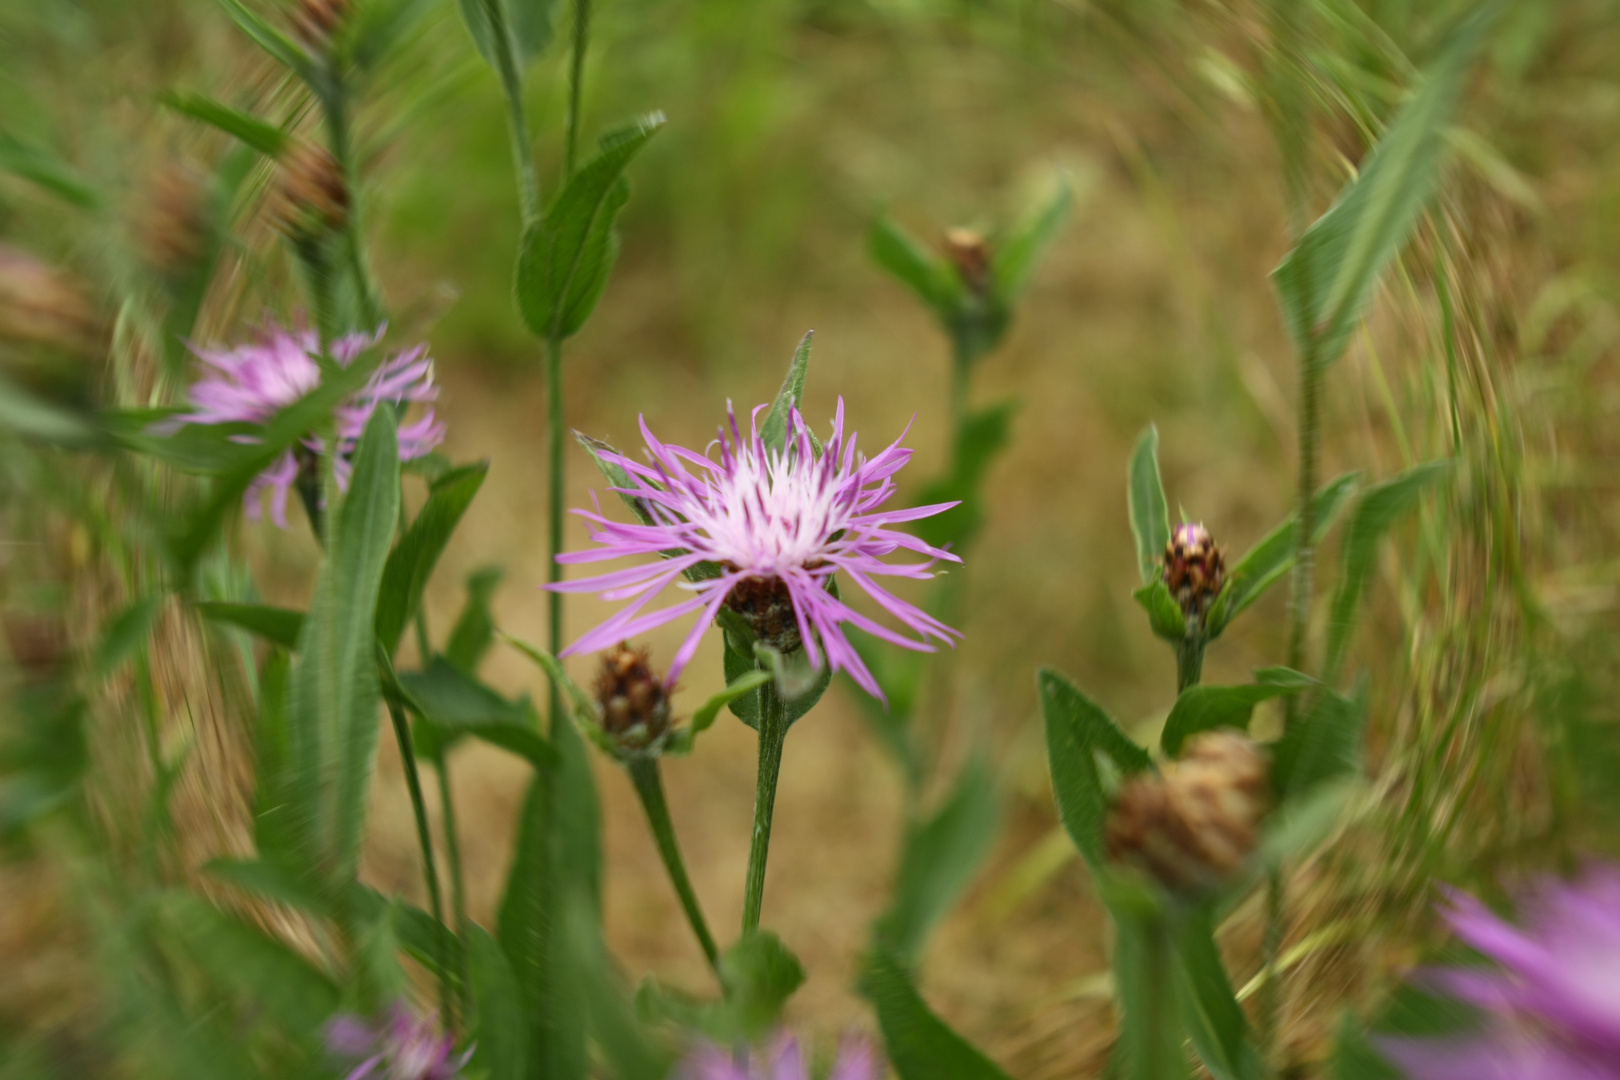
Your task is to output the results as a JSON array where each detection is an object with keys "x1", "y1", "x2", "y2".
[{"x1": 1379, "y1": 866, "x2": 1620, "y2": 1080}]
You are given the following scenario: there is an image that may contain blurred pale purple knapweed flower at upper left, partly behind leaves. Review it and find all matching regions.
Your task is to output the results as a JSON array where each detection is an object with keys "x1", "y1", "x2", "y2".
[{"x1": 177, "y1": 324, "x2": 444, "y2": 528}]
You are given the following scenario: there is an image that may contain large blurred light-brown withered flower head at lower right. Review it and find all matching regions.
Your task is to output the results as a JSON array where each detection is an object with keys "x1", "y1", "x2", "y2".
[{"x1": 1106, "y1": 730, "x2": 1268, "y2": 892}]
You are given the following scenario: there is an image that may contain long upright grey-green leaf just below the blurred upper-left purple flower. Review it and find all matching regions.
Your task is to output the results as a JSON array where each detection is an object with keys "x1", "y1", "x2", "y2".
[{"x1": 290, "y1": 408, "x2": 400, "y2": 884}]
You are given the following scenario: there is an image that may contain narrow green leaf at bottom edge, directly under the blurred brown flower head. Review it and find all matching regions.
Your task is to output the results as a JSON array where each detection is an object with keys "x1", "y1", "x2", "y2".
[{"x1": 1173, "y1": 905, "x2": 1265, "y2": 1080}]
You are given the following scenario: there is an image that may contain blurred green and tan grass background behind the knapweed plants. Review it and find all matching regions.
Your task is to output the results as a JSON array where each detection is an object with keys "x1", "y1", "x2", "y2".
[{"x1": 0, "y1": 0, "x2": 1620, "y2": 1078}]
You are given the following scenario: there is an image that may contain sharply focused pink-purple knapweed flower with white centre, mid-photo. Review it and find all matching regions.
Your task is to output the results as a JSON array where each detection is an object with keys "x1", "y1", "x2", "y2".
[{"x1": 551, "y1": 398, "x2": 961, "y2": 698}]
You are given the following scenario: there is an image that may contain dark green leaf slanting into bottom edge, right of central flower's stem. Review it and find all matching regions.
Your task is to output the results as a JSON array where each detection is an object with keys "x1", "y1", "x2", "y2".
[{"x1": 860, "y1": 947, "x2": 1008, "y2": 1080}]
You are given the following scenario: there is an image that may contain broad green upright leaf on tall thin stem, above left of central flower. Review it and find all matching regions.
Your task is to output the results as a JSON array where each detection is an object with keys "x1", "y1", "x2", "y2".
[{"x1": 517, "y1": 113, "x2": 664, "y2": 338}]
